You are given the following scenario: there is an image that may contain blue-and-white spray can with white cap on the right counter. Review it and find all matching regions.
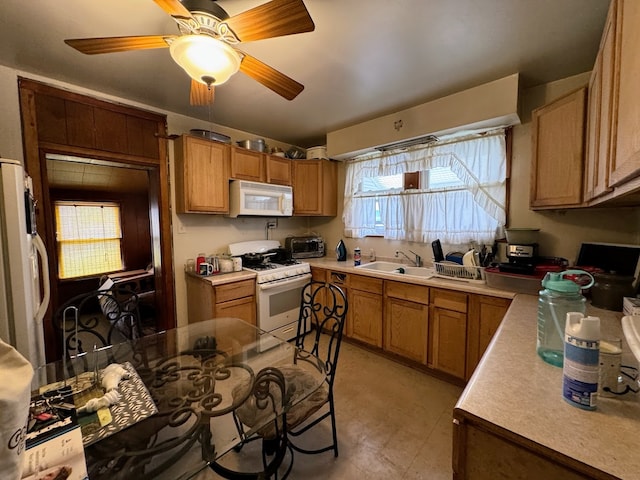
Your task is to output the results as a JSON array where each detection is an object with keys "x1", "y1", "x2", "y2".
[{"x1": 562, "y1": 312, "x2": 600, "y2": 410}]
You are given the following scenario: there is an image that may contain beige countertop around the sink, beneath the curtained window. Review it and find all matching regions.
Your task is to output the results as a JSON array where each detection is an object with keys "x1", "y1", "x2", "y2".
[{"x1": 304, "y1": 257, "x2": 516, "y2": 298}]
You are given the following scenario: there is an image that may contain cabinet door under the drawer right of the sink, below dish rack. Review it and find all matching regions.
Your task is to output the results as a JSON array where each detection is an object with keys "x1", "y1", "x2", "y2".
[{"x1": 429, "y1": 306, "x2": 467, "y2": 379}]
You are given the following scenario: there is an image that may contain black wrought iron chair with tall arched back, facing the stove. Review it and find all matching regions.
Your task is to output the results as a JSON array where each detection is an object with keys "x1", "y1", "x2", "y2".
[{"x1": 235, "y1": 281, "x2": 348, "y2": 478}]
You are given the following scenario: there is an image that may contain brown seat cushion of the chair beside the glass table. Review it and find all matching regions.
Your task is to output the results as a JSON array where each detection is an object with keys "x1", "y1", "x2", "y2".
[{"x1": 233, "y1": 365, "x2": 329, "y2": 438}]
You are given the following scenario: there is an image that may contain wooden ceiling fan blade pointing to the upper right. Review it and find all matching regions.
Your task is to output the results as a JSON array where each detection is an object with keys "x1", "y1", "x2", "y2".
[{"x1": 225, "y1": 0, "x2": 316, "y2": 42}]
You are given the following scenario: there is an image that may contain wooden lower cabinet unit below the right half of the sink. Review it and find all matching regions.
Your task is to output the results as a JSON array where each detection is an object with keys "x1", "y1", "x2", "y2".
[{"x1": 383, "y1": 281, "x2": 429, "y2": 365}]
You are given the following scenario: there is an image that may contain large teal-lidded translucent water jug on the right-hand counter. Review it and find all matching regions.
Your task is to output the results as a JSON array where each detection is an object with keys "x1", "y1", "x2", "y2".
[{"x1": 536, "y1": 270, "x2": 594, "y2": 367}]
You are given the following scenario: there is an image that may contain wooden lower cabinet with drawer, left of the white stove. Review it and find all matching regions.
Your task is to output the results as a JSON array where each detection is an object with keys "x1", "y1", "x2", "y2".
[{"x1": 187, "y1": 274, "x2": 256, "y2": 325}]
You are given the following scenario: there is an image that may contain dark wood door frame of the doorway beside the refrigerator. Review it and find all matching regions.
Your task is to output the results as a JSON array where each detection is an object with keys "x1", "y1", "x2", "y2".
[{"x1": 18, "y1": 77, "x2": 176, "y2": 361}]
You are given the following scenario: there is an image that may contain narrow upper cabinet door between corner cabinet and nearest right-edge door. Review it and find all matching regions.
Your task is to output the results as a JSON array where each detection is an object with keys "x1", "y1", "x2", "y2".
[{"x1": 584, "y1": 2, "x2": 616, "y2": 201}]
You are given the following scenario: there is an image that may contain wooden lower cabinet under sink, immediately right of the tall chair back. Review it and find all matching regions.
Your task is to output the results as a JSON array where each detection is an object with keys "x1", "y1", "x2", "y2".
[{"x1": 347, "y1": 275, "x2": 383, "y2": 347}]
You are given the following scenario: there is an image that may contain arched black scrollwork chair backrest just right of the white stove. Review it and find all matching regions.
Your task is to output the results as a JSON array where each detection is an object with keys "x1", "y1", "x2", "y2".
[{"x1": 296, "y1": 281, "x2": 349, "y2": 388}]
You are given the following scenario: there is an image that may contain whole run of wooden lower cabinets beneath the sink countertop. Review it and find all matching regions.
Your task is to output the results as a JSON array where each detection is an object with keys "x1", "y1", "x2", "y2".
[{"x1": 311, "y1": 267, "x2": 511, "y2": 380}]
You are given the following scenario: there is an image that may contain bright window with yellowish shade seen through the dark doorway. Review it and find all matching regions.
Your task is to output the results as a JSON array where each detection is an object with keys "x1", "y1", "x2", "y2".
[{"x1": 55, "y1": 202, "x2": 123, "y2": 279}]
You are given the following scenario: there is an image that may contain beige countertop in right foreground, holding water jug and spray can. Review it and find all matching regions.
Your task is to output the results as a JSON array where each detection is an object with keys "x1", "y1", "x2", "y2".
[{"x1": 456, "y1": 295, "x2": 640, "y2": 479}]
